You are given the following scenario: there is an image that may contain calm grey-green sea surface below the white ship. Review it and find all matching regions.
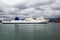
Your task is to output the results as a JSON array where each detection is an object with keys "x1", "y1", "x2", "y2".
[{"x1": 0, "y1": 23, "x2": 60, "y2": 40}]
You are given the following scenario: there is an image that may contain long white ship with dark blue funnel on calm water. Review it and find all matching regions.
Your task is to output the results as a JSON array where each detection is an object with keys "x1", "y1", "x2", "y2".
[{"x1": 2, "y1": 17, "x2": 49, "y2": 24}]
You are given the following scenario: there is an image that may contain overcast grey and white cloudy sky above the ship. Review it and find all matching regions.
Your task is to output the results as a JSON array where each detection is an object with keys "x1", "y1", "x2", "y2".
[{"x1": 0, "y1": 0, "x2": 60, "y2": 17}]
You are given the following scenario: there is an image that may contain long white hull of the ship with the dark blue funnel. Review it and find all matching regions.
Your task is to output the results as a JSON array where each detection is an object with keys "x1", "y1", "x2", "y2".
[{"x1": 2, "y1": 20, "x2": 48, "y2": 24}]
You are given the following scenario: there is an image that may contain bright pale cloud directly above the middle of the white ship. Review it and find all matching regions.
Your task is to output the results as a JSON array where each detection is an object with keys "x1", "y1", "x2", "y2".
[{"x1": 17, "y1": 8, "x2": 44, "y2": 17}]
